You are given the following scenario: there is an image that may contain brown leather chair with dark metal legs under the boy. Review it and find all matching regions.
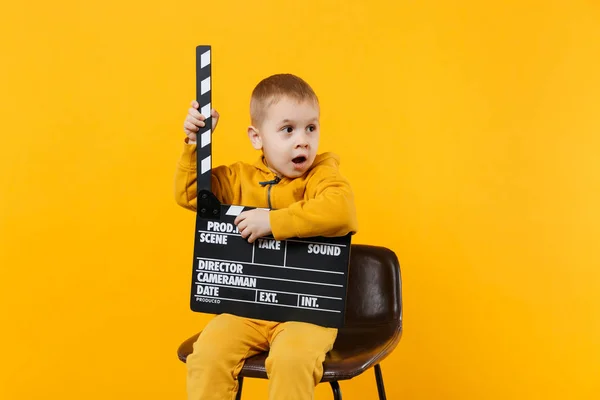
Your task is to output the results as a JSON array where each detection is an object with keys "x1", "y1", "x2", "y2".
[{"x1": 177, "y1": 244, "x2": 402, "y2": 400}]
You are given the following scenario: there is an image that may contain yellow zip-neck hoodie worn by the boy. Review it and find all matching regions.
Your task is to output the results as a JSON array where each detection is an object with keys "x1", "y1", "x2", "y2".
[{"x1": 175, "y1": 144, "x2": 358, "y2": 240}]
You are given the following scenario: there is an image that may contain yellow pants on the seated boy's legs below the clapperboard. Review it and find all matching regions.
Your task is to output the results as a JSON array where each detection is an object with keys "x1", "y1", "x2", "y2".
[{"x1": 186, "y1": 314, "x2": 337, "y2": 400}]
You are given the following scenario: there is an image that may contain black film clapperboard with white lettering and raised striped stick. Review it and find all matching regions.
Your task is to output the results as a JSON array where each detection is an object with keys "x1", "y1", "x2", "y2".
[{"x1": 190, "y1": 46, "x2": 351, "y2": 328}]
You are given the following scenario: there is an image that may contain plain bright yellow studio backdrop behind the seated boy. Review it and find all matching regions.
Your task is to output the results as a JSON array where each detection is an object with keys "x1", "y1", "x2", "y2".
[{"x1": 0, "y1": 0, "x2": 600, "y2": 400}]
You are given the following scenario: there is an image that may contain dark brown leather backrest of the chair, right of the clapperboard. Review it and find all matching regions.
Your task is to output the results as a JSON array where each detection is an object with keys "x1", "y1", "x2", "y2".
[{"x1": 344, "y1": 244, "x2": 402, "y2": 328}]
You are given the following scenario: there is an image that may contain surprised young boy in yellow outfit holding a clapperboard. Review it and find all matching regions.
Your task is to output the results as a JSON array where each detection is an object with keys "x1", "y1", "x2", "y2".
[{"x1": 175, "y1": 74, "x2": 357, "y2": 400}]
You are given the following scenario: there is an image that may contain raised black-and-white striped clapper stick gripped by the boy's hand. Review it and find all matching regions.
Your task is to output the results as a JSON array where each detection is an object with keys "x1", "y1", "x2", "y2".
[{"x1": 196, "y1": 46, "x2": 221, "y2": 219}]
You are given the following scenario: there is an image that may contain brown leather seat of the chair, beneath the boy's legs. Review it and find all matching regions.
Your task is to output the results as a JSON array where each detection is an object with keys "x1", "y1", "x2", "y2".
[{"x1": 177, "y1": 322, "x2": 402, "y2": 382}]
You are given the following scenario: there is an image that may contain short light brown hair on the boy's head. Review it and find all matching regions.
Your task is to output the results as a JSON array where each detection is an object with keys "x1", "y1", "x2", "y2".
[{"x1": 250, "y1": 74, "x2": 319, "y2": 126}]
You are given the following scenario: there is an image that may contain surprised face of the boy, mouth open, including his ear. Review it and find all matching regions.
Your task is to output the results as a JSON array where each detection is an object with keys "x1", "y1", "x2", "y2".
[{"x1": 248, "y1": 97, "x2": 319, "y2": 179}]
